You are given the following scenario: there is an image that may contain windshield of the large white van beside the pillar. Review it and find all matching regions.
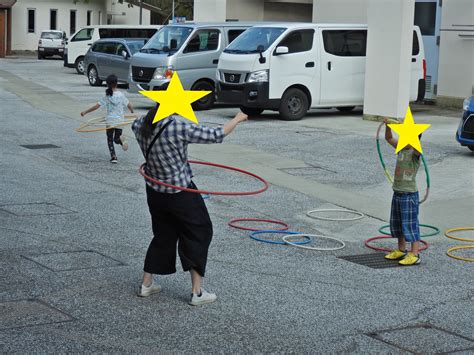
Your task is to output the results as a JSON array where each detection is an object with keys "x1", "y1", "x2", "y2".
[{"x1": 224, "y1": 27, "x2": 286, "y2": 54}]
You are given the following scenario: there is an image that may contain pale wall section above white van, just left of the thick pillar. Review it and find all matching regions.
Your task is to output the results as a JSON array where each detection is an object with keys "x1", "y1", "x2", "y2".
[{"x1": 313, "y1": 0, "x2": 368, "y2": 24}]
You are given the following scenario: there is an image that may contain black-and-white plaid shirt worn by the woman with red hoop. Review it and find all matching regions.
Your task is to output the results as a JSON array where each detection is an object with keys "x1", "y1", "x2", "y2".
[{"x1": 132, "y1": 116, "x2": 224, "y2": 193}]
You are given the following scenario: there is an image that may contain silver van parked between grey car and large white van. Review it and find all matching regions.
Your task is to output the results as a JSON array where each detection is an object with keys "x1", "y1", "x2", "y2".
[{"x1": 128, "y1": 22, "x2": 256, "y2": 110}]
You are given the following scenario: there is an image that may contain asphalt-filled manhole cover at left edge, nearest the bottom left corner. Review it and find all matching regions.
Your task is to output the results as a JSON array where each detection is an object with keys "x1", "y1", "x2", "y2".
[{"x1": 0, "y1": 300, "x2": 74, "y2": 331}]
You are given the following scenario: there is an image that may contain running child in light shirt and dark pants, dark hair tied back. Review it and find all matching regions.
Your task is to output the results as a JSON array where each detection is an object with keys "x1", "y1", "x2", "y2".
[{"x1": 81, "y1": 74, "x2": 133, "y2": 164}]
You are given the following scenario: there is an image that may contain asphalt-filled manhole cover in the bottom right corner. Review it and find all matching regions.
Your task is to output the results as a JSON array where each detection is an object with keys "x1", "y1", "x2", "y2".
[{"x1": 366, "y1": 324, "x2": 474, "y2": 354}]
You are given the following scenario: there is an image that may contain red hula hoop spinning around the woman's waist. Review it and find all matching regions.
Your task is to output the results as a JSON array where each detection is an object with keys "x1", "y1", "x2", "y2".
[{"x1": 139, "y1": 160, "x2": 270, "y2": 196}]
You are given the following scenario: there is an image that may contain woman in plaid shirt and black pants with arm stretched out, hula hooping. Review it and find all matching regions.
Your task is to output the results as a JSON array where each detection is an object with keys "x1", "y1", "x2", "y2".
[{"x1": 132, "y1": 106, "x2": 247, "y2": 305}]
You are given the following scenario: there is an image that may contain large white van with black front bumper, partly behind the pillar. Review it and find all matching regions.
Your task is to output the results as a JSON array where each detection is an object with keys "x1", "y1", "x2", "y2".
[{"x1": 216, "y1": 23, "x2": 426, "y2": 121}]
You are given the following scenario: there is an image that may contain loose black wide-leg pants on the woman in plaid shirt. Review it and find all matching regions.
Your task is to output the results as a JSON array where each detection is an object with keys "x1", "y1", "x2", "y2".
[{"x1": 143, "y1": 182, "x2": 213, "y2": 276}]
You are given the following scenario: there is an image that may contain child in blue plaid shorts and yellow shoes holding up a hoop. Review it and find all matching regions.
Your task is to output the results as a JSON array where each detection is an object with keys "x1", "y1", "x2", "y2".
[{"x1": 384, "y1": 119, "x2": 421, "y2": 266}]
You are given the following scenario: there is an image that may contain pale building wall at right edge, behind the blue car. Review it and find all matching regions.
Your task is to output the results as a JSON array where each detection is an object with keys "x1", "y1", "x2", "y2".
[{"x1": 437, "y1": 0, "x2": 474, "y2": 107}]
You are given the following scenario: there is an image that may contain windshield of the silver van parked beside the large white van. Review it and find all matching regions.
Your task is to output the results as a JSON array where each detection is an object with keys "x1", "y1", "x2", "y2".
[{"x1": 140, "y1": 26, "x2": 193, "y2": 53}]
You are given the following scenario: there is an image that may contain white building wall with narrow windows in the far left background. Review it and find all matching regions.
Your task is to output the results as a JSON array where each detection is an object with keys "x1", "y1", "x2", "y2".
[{"x1": 12, "y1": 0, "x2": 106, "y2": 51}]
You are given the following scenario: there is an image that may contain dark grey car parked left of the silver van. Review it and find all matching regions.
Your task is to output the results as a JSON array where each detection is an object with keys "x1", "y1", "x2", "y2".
[{"x1": 84, "y1": 38, "x2": 146, "y2": 86}]
